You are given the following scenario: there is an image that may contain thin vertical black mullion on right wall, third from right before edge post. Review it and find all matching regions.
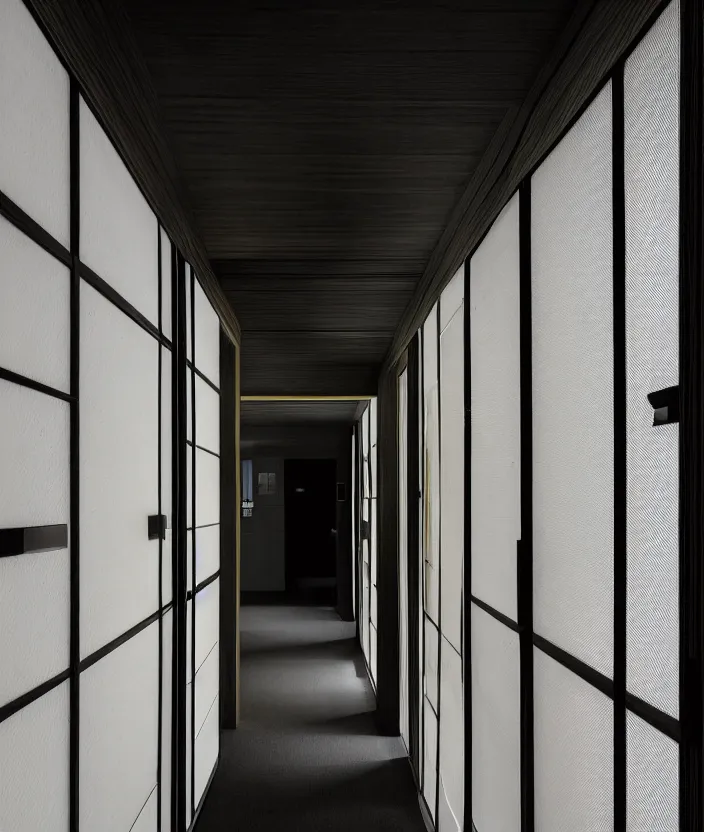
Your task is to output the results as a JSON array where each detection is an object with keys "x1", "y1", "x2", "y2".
[{"x1": 462, "y1": 259, "x2": 472, "y2": 830}]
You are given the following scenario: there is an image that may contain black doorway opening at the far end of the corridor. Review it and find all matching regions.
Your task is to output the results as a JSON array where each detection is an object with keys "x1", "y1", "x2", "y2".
[{"x1": 284, "y1": 459, "x2": 337, "y2": 606}]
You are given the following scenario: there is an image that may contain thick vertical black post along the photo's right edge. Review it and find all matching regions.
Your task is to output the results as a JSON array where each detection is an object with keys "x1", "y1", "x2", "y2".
[{"x1": 679, "y1": 0, "x2": 704, "y2": 832}]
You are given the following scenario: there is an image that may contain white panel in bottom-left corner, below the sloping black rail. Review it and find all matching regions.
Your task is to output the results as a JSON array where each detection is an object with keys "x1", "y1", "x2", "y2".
[{"x1": 0, "y1": 682, "x2": 69, "y2": 832}]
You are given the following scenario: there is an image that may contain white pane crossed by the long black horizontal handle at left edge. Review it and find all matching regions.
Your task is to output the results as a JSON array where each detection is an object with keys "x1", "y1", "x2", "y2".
[{"x1": 0, "y1": 381, "x2": 69, "y2": 705}]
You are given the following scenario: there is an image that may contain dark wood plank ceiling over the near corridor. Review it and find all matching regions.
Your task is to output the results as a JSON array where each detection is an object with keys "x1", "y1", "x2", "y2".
[{"x1": 123, "y1": 0, "x2": 575, "y2": 404}]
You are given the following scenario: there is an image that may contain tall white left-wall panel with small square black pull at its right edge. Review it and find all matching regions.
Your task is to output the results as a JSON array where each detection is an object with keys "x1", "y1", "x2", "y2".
[{"x1": 80, "y1": 283, "x2": 159, "y2": 656}]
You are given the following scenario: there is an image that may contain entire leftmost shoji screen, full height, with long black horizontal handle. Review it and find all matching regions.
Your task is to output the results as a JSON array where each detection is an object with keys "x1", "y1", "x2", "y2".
[{"x1": 0, "y1": 0, "x2": 74, "y2": 832}]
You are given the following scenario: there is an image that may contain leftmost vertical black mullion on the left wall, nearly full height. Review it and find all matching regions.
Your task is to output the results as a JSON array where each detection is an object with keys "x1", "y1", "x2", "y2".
[{"x1": 69, "y1": 79, "x2": 81, "y2": 832}]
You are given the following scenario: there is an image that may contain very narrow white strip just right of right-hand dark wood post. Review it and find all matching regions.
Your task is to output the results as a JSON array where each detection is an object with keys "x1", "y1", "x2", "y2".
[{"x1": 398, "y1": 370, "x2": 410, "y2": 749}]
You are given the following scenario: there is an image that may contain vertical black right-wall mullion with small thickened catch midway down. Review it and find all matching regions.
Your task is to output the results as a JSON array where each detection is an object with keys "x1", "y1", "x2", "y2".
[{"x1": 517, "y1": 179, "x2": 535, "y2": 832}]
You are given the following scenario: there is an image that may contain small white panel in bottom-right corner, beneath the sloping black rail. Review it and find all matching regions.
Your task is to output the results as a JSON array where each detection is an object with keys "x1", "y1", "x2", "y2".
[{"x1": 626, "y1": 712, "x2": 680, "y2": 832}]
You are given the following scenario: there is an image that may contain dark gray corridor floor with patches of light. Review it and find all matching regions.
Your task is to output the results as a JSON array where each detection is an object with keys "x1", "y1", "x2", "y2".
[{"x1": 197, "y1": 607, "x2": 425, "y2": 832}]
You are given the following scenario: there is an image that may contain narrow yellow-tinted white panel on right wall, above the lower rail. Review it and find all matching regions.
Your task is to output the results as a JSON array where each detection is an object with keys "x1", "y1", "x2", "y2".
[{"x1": 423, "y1": 305, "x2": 440, "y2": 622}]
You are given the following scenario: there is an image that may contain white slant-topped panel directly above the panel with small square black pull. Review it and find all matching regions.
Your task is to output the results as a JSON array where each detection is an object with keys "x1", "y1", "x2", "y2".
[{"x1": 80, "y1": 100, "x2": 159, "y2": 326}]
